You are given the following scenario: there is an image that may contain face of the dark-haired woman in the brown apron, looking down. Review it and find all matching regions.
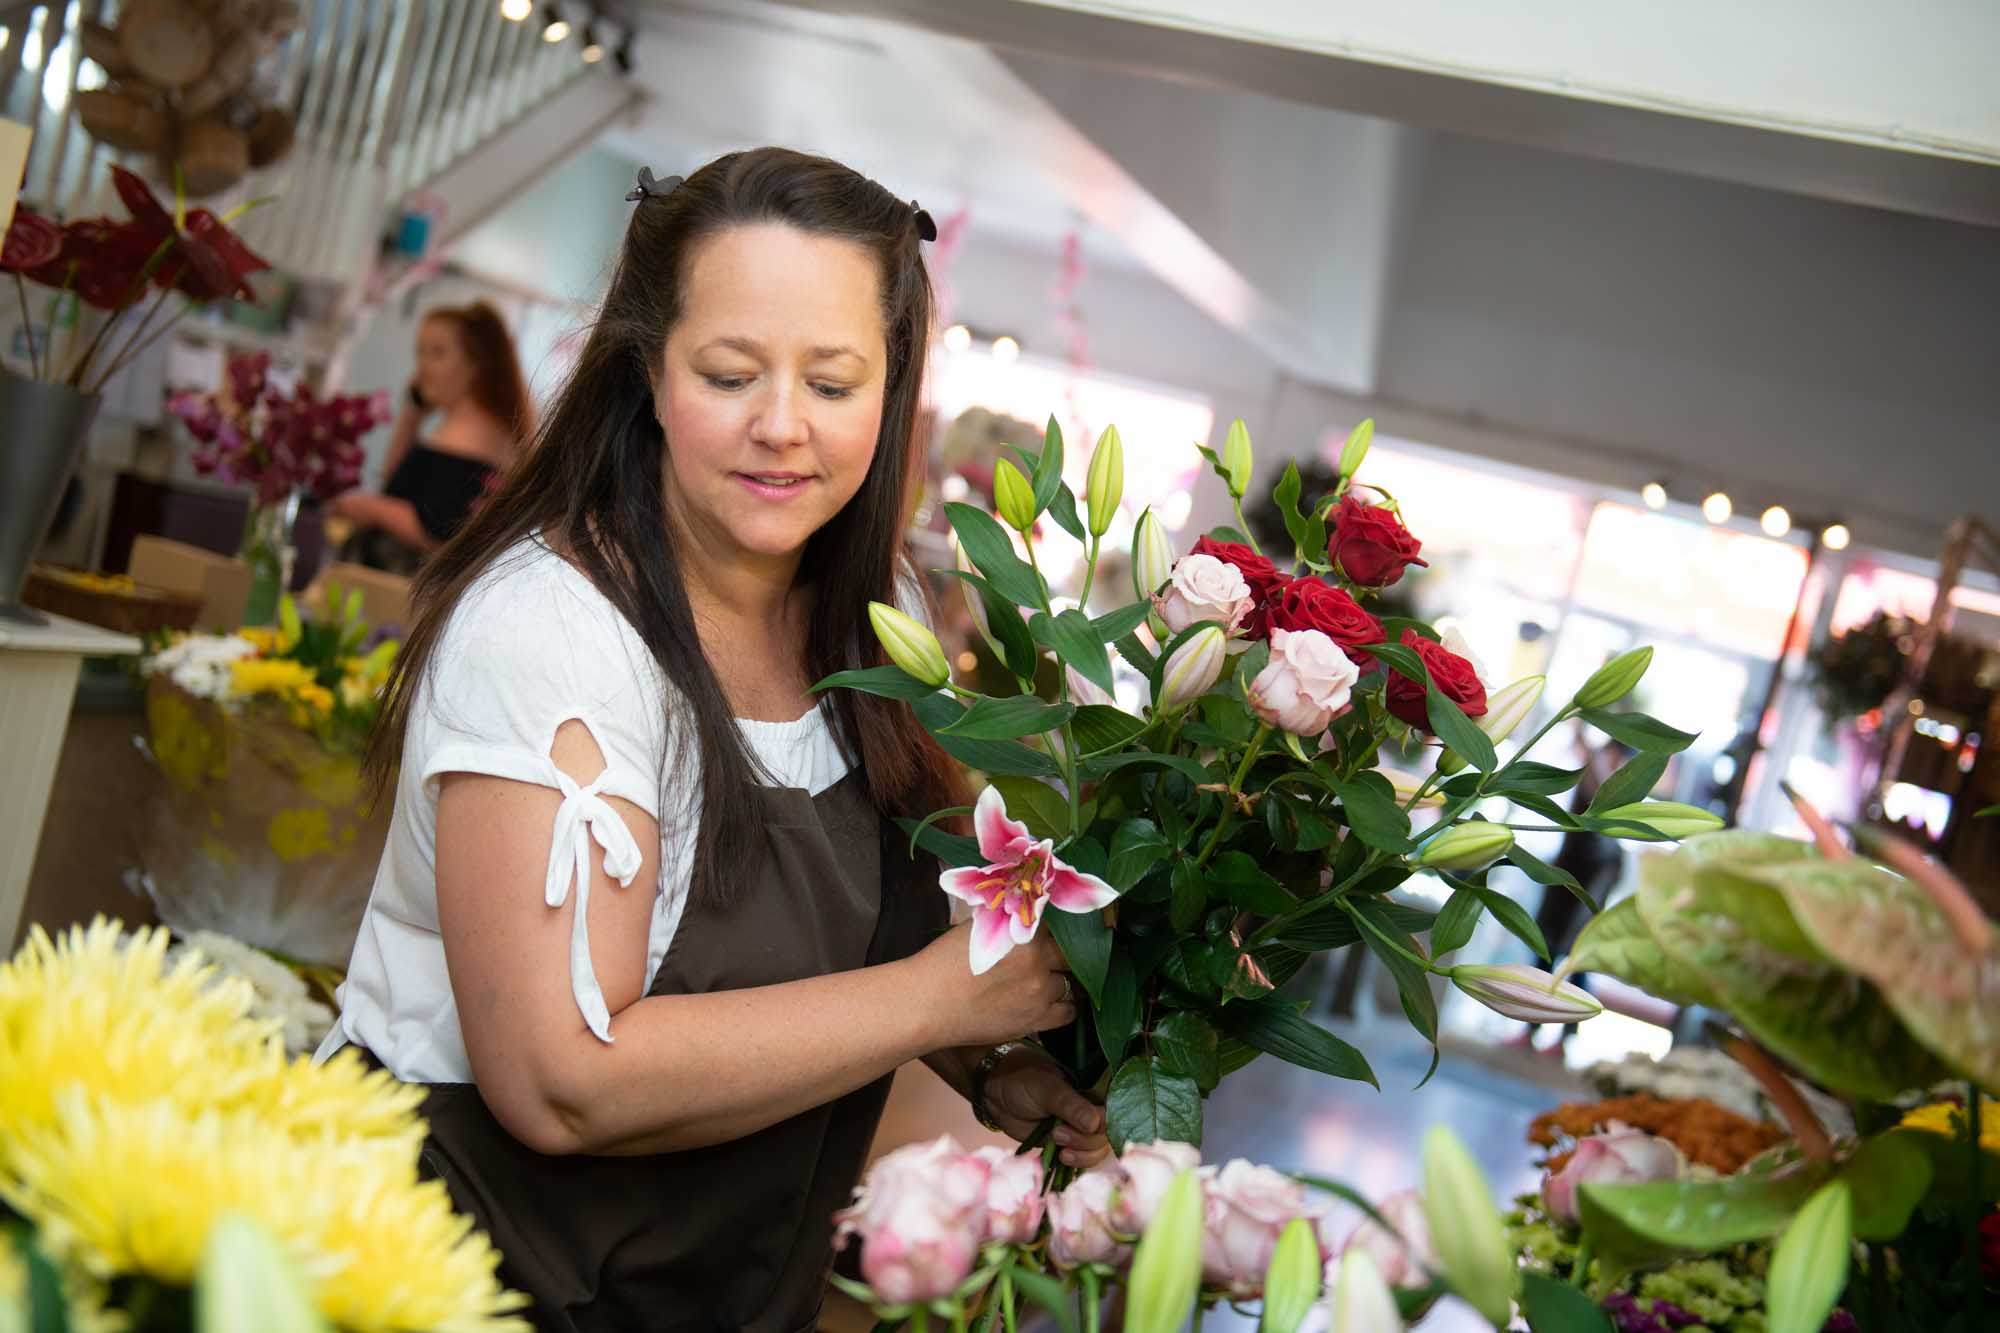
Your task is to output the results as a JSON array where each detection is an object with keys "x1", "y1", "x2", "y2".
[{"x1": 654, "y1": 222, "x2": 888, "y2": 558}]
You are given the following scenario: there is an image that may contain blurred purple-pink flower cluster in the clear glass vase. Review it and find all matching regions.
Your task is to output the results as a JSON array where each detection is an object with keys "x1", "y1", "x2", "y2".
[{"x1": 166, "y1": 352, "x2": 390, "y2": 504}]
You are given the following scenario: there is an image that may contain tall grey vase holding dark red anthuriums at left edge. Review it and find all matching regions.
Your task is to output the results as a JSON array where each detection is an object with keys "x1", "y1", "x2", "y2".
[{"x1": 0, "y1": 370, "x2": 98, "y2": 624}]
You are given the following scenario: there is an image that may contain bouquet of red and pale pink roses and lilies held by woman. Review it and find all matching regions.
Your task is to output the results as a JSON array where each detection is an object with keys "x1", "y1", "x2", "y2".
[{"x1": 836, "y1": 422, "x2": 1720, "y2": 1149}]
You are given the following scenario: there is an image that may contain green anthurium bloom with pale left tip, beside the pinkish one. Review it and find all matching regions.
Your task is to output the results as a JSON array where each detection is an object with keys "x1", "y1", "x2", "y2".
[{"x1": 1638, "y1": 857, "x2": 1946, "y2": 1101}]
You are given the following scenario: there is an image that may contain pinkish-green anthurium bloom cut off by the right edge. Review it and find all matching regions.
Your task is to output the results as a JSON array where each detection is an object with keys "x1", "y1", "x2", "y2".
[{"x1": 1744, "y1": 859, "x2": 2000, "y2": 1087}]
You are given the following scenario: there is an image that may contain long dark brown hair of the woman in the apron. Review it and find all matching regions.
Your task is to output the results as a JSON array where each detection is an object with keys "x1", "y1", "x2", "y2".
[{"x1": 380, "y1": 148, "x2": 962, "y2": 897}]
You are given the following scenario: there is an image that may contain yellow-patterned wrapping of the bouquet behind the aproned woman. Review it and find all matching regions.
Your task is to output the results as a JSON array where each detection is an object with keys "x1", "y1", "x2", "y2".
[{"x1": 138, "y1": 677, "x2": 390, "y2": 967}]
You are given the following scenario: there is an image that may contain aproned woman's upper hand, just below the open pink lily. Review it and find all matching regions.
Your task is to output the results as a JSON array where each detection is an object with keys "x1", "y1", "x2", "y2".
[{"x1": 914, "y1": 923, "x2": 1076, "y2": 1047}]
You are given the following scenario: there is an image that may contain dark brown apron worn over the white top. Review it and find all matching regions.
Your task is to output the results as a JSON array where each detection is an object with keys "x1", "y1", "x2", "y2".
[{"x1": 376, "y1": 771, "x2": 948, "y2": 1333}]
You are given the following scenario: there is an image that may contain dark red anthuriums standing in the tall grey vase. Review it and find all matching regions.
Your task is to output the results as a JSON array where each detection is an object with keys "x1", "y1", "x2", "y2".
[{"x1": 0, "y1": 166, "x2": 270, "y2": 394}]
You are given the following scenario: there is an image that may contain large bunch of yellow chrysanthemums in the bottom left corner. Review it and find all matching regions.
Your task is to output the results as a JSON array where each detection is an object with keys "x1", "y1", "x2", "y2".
[{"x1": 0, "y1": 919, "x2": 528, "y2": 1333}]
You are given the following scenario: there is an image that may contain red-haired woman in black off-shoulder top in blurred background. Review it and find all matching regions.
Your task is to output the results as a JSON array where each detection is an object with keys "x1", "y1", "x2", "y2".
[{"x1": 332, "y1": 300, "x2": 534, "y2": 572}]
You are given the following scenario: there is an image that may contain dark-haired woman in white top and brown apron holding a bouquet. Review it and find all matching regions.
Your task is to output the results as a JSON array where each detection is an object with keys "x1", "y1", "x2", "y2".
[{"x1": 316, "y1": 148, "x2": 1106, "y2": 1331}]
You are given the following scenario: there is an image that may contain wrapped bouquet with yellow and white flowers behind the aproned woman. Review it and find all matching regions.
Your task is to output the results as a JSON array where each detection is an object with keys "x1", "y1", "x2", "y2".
[{"x1": 134, "y1": 588, "x2": 398, "y2": 967}]
